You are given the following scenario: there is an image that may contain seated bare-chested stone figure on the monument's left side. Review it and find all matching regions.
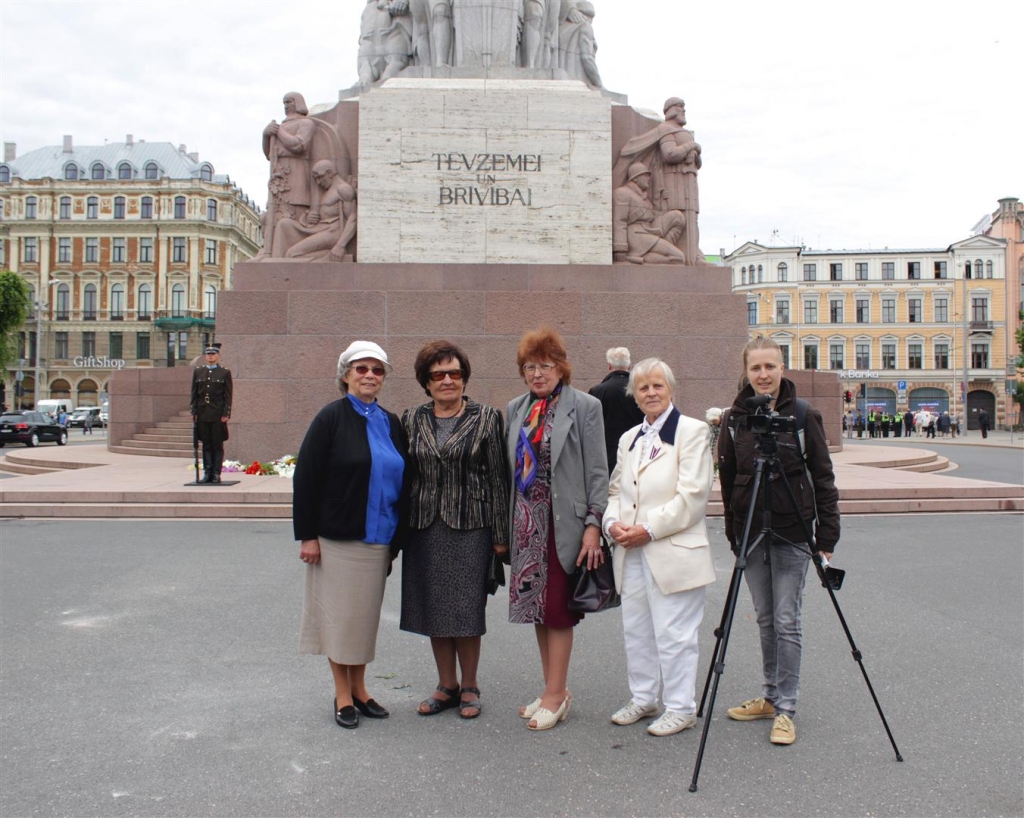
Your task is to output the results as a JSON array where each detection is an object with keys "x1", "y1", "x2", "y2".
[{"x1": 272, "y1": 159, "x2": 356, "y2": 261}]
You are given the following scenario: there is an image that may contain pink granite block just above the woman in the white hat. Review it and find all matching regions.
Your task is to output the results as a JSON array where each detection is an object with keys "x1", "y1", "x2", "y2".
[{"x1": 288, "y1": 290, "x2": 386, "y2": 335}]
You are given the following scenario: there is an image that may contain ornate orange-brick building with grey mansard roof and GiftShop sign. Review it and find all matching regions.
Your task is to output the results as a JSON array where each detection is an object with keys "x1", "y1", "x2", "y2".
[{"x1": 0, "y1": 135, "x2": 261, "y2": 406}]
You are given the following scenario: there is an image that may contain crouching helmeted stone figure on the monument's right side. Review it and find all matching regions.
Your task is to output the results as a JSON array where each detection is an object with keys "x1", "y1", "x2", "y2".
[{"x1": 611, "y1": 162, "x2": 686, "y2": 264}]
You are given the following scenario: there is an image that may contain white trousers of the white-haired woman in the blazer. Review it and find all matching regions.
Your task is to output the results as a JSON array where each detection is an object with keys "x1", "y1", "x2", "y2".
[{"x1": 622, "y1": 548, "x2": 705, "y2": 713}]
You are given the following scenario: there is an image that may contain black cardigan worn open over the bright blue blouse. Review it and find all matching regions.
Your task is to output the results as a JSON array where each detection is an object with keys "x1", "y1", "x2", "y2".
[{"x1": 292, "y1": 397, "x2": 412, "y2": 552}]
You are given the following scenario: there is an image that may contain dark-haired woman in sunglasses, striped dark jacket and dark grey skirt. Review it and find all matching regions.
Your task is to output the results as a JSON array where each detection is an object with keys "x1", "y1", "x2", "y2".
[{"x1": 400, "y1": 341, "x2": 510, "y2": 719}]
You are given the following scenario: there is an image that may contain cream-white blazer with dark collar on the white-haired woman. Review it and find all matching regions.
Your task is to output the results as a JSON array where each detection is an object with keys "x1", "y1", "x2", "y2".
[{"x1": 605, "y1": 407, "x2": 715, "y2": 594}]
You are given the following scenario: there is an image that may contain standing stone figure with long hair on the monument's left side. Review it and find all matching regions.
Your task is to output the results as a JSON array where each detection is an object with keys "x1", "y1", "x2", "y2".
[{"x1": 255, "y1": 91, "x2": 351, "y2": 261}]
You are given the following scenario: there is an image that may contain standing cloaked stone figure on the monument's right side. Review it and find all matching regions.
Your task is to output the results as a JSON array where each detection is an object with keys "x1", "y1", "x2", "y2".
[{"x1": 613, "y1": 96, "x2": 705, "y2": 264}]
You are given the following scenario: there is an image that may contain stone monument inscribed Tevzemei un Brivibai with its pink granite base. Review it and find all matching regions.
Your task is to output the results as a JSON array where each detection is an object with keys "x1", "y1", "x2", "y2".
[{"x1": 111, "y1": 0, "x2": 839, "y2": 461}]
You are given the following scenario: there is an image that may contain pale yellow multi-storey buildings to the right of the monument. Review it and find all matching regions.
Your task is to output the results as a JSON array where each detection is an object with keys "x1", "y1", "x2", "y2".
[{"x1": 723, "y1": 200, "x2": 1024, "y2": 428}]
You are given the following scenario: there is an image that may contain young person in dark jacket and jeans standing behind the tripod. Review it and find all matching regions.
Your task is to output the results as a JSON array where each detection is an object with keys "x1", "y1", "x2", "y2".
[{"x1": 718, "y1": 336, "x2": 840, "y2": 744}]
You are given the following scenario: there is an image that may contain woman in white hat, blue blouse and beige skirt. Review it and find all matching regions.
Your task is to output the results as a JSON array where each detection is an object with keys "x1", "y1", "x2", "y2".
[{"x1": 292, "y1": 341, "x2": 410, "y2": 729}]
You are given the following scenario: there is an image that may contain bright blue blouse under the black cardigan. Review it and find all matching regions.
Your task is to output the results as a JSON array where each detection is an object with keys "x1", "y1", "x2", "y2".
[{"x1": 347, "y1": 392, "x2": 406, "y2": 545}]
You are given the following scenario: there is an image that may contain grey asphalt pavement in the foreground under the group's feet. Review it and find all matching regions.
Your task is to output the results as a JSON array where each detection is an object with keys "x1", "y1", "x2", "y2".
[{"x1": 0, "y1": 514, "x2": 1024, "y2": 818}]
